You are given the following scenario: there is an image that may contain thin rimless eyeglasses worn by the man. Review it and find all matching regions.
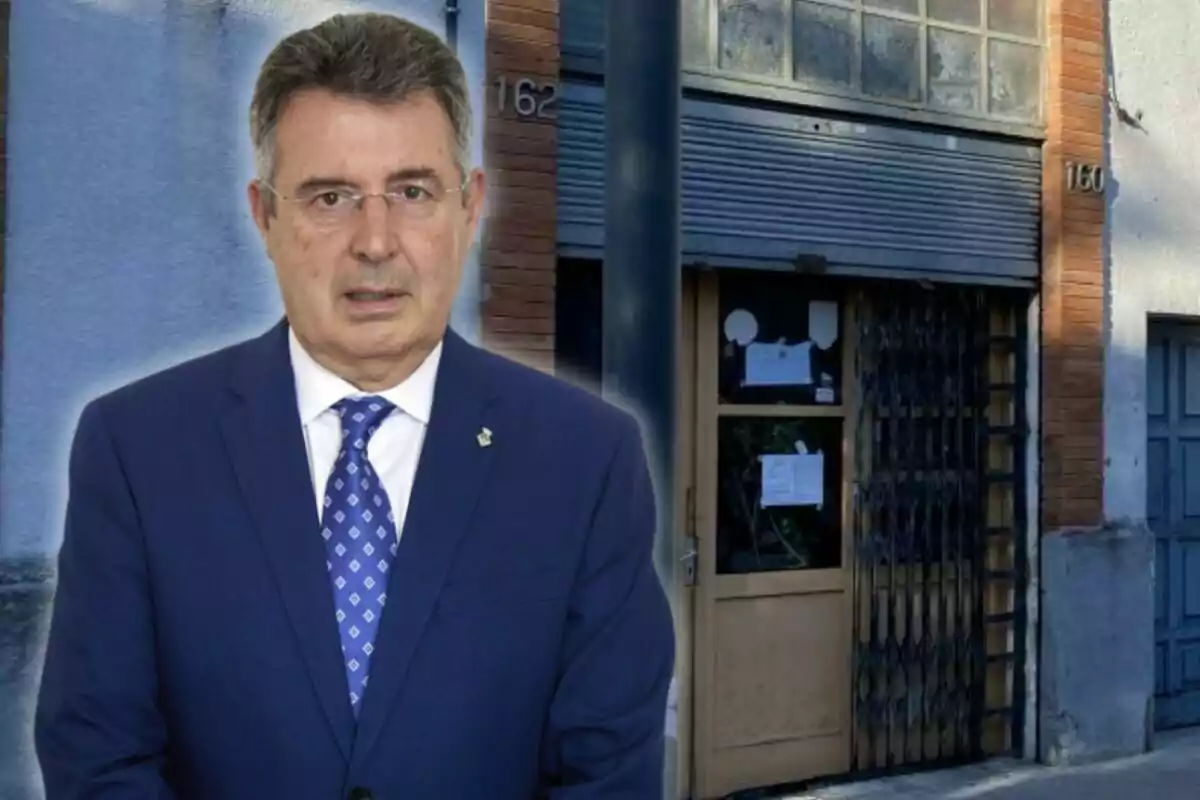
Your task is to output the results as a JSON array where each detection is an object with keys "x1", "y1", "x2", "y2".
[{"x1": 258, "y1": 179, "x2": 467, "y2": 229}]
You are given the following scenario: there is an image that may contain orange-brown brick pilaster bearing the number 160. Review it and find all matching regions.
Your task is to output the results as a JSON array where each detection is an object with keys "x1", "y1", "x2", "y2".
[{"x1": 1042, "y1": 0, "x2": 1108, "y2": 531}]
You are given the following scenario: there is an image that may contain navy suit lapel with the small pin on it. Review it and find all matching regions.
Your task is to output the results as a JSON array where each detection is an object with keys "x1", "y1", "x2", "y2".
[{"x1": 350, "y1": 331, "x2": 504, "y2": 771}]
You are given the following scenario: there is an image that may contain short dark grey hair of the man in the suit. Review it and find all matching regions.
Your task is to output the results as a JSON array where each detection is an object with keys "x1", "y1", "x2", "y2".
[{"x1": 250, "y1": 13, "x2": 470, "y2": 188}]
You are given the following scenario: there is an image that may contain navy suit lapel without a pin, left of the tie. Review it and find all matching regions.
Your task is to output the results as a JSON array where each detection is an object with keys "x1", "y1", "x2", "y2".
[{"x1": 222, "y1": 323, "x2": 354, "y2": 759}]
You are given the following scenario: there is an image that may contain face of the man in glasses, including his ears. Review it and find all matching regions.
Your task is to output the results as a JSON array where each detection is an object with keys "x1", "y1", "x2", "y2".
[{"x1": 248, "y1": 90, "x2": 484, "y2": 385}]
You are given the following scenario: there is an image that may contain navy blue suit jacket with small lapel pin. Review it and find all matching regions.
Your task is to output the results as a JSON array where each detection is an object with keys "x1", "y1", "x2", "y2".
[{"x1": 35, "y1": 323, "x2": 674, "y2": 800}]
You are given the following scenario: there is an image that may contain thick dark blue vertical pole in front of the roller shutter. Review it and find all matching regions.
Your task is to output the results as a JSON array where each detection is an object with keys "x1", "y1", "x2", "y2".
[{"x1": 601, "y1": 0, "x2": 682, "y2": 798}]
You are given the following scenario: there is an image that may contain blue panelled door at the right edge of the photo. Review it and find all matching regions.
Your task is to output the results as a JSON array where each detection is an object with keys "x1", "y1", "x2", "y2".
[{"x1": 1146, "y1": 325, "x2": 1200, "y2": 729}]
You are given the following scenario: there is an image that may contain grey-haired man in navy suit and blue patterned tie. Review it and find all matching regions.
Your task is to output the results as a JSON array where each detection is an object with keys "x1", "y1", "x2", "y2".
[{"x1": 36, "y1": 14, "x2": 674, "y2": 800}]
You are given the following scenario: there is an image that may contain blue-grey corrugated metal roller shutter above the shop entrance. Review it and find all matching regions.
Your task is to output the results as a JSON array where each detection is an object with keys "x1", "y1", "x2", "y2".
[{"x1": 558, "y1": 84, "x2": 1042, "y2": 282}]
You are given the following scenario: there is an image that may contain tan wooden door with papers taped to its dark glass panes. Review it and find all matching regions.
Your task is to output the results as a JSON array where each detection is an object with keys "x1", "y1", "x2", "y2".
[{"x1": 684, "y1": 271, "x2": 853, "y2": 799}]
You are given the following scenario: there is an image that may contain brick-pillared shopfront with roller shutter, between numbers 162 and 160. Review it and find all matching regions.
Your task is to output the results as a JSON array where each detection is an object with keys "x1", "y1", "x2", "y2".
[{"x1": 481, "y1": 0, "x2": 1132, "y2": 798}]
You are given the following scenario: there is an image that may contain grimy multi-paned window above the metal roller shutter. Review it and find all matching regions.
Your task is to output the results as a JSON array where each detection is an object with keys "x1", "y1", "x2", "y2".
[{"x1": 683, "y1": 0, "x2": 1043, "y2": 126}]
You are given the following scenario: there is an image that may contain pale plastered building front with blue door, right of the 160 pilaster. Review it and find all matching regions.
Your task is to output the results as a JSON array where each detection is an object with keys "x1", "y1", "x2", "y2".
[{"x1": 1104, "y1": 0, "x2": 1200, "y2": 728}]
